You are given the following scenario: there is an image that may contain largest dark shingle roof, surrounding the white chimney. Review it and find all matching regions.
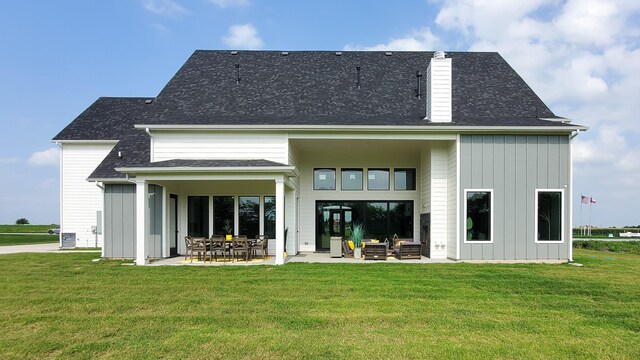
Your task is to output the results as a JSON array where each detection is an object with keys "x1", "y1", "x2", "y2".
[{"x1": 139, "y1": 50, "x2": 556, "y2": 126}]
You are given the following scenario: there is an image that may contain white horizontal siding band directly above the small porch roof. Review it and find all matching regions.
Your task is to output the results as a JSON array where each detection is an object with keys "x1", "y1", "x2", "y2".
[{"x1": 151, "y1": 132, "x2": 289, "y2": 164}]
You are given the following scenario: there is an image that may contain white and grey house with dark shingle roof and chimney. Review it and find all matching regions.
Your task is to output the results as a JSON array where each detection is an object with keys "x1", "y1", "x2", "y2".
[{"x1": 53, "y1": 51, "x2": 586, "y2": 264}]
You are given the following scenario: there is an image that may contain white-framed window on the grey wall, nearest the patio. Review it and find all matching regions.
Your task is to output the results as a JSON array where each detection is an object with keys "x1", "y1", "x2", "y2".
[{"x1": 465, "y1": 190, "x2": 493, "y2": 242}]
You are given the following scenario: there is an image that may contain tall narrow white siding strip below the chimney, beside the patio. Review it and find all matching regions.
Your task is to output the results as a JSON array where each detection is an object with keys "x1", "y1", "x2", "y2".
[{"x1": 431, "y1": 143, "x2": 449, "y2": 259}]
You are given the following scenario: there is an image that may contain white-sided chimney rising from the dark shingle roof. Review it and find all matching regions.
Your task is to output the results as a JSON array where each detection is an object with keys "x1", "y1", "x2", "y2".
[{"x1": 427, "y1": 58, "x2": 452, "y2": 122}]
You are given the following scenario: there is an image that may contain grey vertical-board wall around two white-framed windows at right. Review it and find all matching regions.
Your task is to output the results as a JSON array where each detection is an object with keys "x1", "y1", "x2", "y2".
[{"x1": 459, "y1": 135, "x2": 571, "y2": 260}]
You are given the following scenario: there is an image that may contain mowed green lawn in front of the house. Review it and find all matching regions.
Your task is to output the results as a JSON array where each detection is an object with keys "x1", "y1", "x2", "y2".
[{"x1": 0, "y1": 249, "x2": 640, "y2": 359}]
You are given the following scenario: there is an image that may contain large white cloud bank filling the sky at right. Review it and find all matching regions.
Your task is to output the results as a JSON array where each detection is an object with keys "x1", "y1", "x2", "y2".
[{"x1": 435, "y1": 0, "x2": 640, "y2": 226}]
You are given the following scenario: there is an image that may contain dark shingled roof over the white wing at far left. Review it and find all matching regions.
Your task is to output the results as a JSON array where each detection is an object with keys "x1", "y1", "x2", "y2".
[{"x1": 53, "y1": 97, "x2": 153, "y2": 140}]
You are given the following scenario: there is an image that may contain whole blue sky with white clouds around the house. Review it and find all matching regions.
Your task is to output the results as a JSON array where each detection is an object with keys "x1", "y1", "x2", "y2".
[{"x1": 0, "y1": 0, "x2": 640, "y2": 227}]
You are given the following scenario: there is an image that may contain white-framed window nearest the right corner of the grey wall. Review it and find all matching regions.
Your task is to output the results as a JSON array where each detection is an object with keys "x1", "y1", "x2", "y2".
[{"x1": 536, "y1": 190, "x2": 563, "y2": 242}]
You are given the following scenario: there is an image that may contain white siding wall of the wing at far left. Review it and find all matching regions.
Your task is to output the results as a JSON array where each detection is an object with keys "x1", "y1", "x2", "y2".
[{"x1": 60, "y1": 143, "x2": 114, "y2": 247}]
